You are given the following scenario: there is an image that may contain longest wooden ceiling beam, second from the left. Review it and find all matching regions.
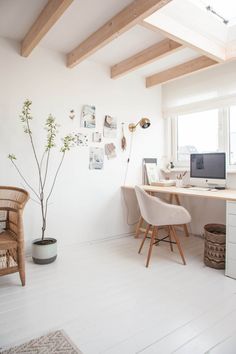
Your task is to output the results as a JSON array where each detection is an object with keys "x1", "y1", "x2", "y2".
[{"x1": 67, "y1": 0, "x2": 172, "y2": 68}]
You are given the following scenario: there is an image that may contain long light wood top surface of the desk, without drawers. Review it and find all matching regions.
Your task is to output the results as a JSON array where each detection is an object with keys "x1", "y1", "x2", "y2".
[{"x1": 122, "y1": 185, "x2": 236, "y2": 201}]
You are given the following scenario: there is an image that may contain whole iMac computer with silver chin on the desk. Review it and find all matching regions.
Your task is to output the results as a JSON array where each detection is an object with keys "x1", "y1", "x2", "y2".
[{"x1": 190, "y1": 152, "x2": 226, "y2": 189}]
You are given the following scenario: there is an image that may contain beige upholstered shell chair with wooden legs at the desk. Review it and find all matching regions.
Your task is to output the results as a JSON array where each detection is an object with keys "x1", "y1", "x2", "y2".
[{"x1": 135, "y1": 186, "x2": 191, "y2": 267}]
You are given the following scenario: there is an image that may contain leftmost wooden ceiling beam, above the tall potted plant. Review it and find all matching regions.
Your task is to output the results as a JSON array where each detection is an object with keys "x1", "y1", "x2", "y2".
[{"x1": 21, "y1": 0, "x2": 73, "y2": 57}]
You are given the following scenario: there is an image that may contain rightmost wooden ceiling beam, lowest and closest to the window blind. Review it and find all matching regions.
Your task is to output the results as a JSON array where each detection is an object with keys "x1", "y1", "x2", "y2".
[{"x1": 146, "y1": 56, "x2": 218, "y2": 87}]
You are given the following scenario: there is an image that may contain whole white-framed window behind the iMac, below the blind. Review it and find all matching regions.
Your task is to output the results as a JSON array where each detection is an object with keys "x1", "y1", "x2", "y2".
[{"x1": 170, "y1": 105, "x2": 236, "y2": 168}]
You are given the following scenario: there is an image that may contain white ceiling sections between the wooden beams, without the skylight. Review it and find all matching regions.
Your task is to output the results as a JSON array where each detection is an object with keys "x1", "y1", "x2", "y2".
[{"x1": 0, "y1": 0, "x2": 201, "y2": 76}]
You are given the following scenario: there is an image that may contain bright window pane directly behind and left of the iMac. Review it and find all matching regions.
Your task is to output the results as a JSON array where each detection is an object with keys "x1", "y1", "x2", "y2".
[{"x1": 177, "y1": 109, "x2": 219, "y2": 161}]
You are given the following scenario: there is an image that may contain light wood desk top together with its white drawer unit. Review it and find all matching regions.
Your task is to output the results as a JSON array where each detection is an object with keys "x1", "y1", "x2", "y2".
[{"x1": 123, "y1": 185, "x2": 236, "y2": 279}]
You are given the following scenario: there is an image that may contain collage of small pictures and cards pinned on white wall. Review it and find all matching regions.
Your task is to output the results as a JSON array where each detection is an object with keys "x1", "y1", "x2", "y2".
[{"x1": 69, "y1": 105, "x2": 117, "y2": 170}]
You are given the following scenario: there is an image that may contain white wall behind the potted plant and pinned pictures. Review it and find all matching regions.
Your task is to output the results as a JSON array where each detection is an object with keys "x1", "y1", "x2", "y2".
[{"x1": 0, "y1": 38, "x2": 163, "y2": 252}]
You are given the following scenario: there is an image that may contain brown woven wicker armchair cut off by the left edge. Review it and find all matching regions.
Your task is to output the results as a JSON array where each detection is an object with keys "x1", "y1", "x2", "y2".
[{"x1": 0, "y1": 186, "x2": 29, "y2": 286}]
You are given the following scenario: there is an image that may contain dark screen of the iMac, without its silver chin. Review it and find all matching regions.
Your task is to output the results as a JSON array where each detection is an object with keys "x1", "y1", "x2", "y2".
[{"x1": 190, "y1": 152, "x2": 226, "y2": 179}]
